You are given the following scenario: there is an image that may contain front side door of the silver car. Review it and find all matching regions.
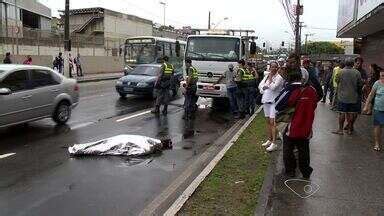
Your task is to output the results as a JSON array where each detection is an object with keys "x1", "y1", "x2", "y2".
[{"x1": 0, "y1": 70, "x2": 32, "y2": 127}]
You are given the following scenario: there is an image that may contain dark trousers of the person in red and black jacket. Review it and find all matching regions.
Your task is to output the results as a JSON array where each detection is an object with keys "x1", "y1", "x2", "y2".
[{"x1": 283, "y1": 135, "x2": 313, "y2": 177}]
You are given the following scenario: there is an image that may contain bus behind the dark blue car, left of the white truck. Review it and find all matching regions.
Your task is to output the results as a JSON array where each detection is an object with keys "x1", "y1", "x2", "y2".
[{"x1": 124, "y1": 36, "x2": 186, "y2": 74}]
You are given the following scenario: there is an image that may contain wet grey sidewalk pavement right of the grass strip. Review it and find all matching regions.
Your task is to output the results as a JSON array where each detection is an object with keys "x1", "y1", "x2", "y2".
[{"x1": 266, "y1": 104, "x2": 384, "y2": 216}]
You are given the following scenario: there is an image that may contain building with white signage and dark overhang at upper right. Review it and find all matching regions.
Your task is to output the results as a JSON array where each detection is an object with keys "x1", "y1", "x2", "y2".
[{"x1": 337, "y1": 0, "x2": 384, "y2": 67}]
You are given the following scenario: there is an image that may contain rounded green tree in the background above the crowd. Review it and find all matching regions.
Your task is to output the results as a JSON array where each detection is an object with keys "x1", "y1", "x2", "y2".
[{"x1": 302, "y1": 41, "x2": 344, "y2": 55}]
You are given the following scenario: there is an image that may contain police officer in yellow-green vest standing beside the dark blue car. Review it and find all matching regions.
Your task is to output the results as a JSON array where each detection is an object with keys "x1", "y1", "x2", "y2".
[{"x1": 151, "y1": 56, "x2": 175, "y2": 115}]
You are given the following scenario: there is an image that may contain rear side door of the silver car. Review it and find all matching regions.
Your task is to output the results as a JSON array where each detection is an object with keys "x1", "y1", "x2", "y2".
[{"x1": 30, "y1": 69, "x2": 61, "y2": 118}]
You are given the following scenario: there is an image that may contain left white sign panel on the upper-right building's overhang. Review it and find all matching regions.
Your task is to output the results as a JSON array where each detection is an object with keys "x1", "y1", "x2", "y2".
[{"x1": 337, "y1": 0, "x2": 356, "y2": 31}]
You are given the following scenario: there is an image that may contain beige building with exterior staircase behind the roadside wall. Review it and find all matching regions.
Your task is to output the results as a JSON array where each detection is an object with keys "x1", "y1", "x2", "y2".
[{"x1": 65, "y1": 8, "x2": 153, "y2": 56}]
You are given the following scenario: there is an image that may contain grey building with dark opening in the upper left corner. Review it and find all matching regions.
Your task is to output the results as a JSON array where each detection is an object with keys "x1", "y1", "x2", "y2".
[{"x1": 0, "y1": 0, "x2": 51, "y2": 37}]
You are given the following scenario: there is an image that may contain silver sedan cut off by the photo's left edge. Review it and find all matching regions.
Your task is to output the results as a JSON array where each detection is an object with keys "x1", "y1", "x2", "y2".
[{"x1": 0, "y1": 64, "x2": 79, "y2": 128}]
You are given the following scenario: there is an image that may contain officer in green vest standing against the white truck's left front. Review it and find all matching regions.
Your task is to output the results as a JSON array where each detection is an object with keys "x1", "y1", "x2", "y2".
[{"x1": 184, "y1": 59, "x2": 198, "y2": 120}]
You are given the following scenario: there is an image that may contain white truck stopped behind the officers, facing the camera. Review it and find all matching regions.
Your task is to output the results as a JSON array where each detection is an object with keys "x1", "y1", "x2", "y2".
[{"x1": 184, "y1": 31, "x2": 256, "y2": 99}]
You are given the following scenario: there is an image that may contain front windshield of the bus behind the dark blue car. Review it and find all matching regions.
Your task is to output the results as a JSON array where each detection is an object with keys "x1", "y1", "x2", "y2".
[{"x1": 125, "y1": 44, "x2": 156, "y2": 64}]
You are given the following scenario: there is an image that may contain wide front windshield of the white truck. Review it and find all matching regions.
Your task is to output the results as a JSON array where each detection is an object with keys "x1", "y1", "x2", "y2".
[{"x1": 186, "y1": 37, "x2": 240, "y2": 62}]
